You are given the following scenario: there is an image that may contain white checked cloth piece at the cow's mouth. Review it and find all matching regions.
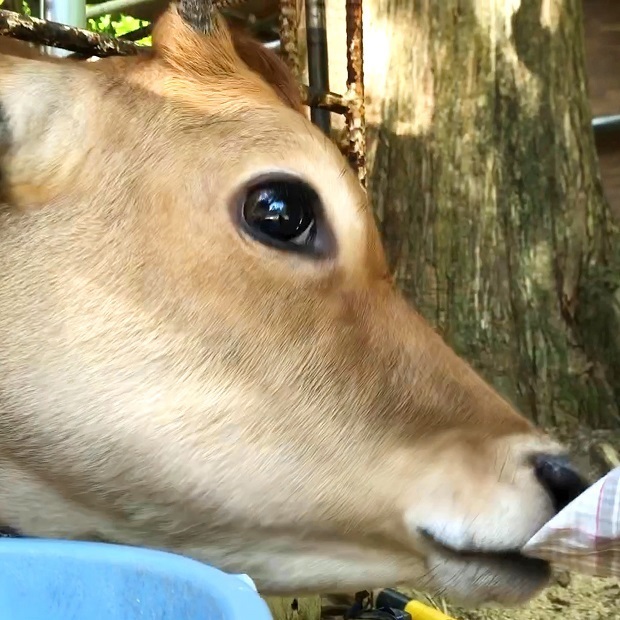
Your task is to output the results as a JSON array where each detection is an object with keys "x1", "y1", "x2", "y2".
[{"x1": 522, "y1": 467, "x2": 620, "y2": 577}]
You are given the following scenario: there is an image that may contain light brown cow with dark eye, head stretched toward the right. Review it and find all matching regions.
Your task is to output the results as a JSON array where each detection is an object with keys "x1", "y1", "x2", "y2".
[{"x1": 0, "y1": 0, "x2": 586, "y2": 605}]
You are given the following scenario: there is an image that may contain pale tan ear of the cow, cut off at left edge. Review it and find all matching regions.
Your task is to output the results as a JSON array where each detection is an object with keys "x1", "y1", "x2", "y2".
[{"x1": 0, "y1": 54, "x2": 97, "y2": 203}]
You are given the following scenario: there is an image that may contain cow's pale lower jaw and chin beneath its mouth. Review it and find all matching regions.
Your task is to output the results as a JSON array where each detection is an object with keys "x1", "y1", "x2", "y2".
[{"x1": 174, "y1": 532, "x2": 550, "y2": 607}]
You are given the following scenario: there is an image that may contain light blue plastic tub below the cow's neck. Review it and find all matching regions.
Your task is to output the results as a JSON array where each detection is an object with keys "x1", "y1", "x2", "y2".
[{"x1": 0, "y1": 538, "x2": 273, "y2": 620}]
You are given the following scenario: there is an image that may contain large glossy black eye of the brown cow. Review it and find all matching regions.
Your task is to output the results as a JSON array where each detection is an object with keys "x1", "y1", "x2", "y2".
[{"x1": 242, "y1": 179, "x2": 321, "y2": 250}]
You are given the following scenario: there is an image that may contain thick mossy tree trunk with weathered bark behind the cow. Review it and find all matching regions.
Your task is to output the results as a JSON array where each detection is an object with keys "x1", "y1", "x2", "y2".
[{"x1": 320, "y1": 0, "x2": 620, "y2": 425}]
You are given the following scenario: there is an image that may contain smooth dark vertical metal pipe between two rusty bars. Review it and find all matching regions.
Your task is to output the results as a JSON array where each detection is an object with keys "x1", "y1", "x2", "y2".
[{"x1": 306, "y1": 0, "x2": 331, "y2": 135}]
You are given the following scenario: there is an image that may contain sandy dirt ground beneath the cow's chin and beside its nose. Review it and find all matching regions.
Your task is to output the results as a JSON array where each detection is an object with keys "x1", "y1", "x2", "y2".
[{"x1": 269, "y1": 428, "x2": 620, "y2": 620}]
